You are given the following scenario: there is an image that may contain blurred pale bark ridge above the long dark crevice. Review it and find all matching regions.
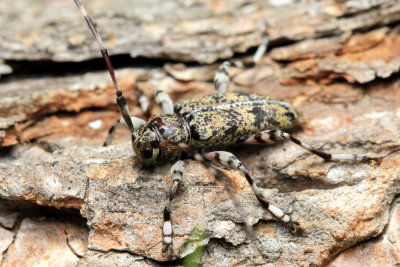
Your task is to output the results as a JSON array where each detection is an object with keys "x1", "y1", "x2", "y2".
[{"x1": 0, "y1": 0, "x2": 400, "y2": 63}]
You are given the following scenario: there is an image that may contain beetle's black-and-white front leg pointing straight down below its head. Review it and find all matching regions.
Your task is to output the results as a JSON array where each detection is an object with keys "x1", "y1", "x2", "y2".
[{"x1": 162, "y1": 160, "x2": 185, "y2": 258}]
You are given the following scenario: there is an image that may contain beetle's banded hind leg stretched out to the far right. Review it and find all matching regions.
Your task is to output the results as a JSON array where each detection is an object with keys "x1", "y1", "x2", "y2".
[{"x1": 244, "y1": 130, "x2": 383, "y2": 164}]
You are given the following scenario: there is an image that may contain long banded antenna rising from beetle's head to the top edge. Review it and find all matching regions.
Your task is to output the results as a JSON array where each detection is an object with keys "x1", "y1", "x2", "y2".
[{"x1": 74, "y1": 0, "x2": 134, "y2": 132}]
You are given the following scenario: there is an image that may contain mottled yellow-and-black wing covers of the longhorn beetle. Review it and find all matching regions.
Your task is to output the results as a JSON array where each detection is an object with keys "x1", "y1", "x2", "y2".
[{"x1": 174, "y1": 93, "x2": 297, "y2": 147}]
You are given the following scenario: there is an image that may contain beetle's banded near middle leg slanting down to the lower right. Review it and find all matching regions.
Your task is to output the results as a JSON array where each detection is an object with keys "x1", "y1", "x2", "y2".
[{"x1": 178, "y1": 144, "x2": 303, "y2": 234}]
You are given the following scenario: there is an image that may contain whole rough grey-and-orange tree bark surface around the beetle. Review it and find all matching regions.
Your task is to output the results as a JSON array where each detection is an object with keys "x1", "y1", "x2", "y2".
[{"x1": 0, "y1": 0, "x2": 400, "y2": 266}]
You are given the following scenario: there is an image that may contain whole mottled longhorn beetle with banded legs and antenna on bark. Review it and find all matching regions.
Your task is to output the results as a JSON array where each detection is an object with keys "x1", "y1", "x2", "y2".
[{"x1": 74, "y1": 0, "x2": 382, "y2": 258}]
